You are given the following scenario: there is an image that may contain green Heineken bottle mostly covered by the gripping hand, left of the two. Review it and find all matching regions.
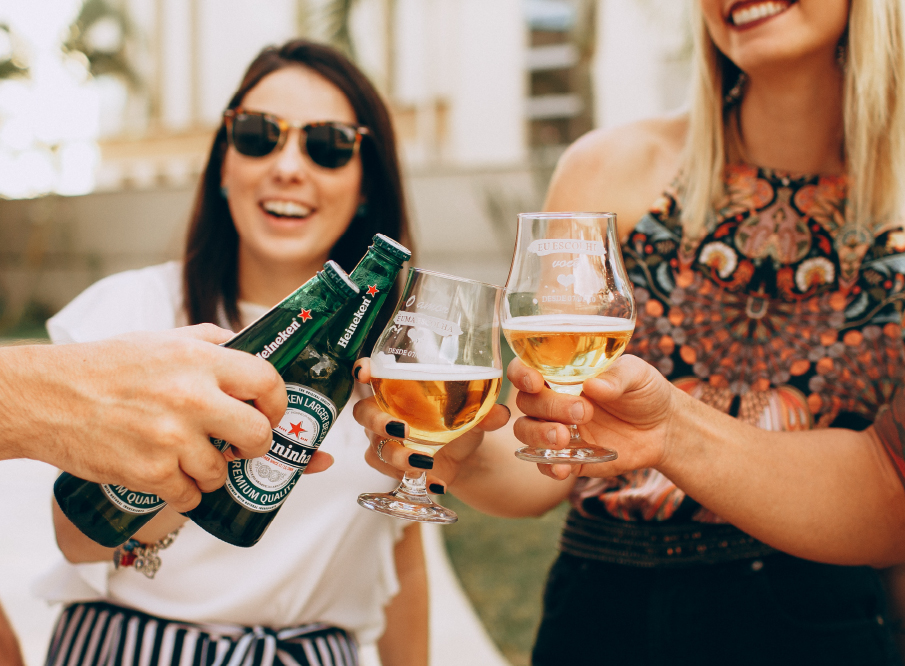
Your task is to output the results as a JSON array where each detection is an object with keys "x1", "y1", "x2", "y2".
[{"x1": 53, "y1": 261, "x2": 358, "y2": 548}]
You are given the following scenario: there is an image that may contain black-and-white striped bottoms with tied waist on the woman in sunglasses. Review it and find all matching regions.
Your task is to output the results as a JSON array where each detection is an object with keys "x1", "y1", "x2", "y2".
[{"x1": 45, "y1": 602, "x2": 358, "y2": 666}]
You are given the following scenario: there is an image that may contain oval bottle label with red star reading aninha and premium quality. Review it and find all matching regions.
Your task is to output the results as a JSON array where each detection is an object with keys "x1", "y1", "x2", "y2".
[{"x1": 226, "y1": 384, "x2": 336, "y2": 513}]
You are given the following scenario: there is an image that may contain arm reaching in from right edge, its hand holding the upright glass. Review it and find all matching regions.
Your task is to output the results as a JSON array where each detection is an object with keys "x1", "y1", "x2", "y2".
[{"x1": 509, "y1": 356, "x2": 905, "y2": 565}]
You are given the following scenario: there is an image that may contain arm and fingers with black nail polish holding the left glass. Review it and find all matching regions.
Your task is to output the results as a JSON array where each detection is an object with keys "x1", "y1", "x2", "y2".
[{"x1": 353, "y1": 359, "x2": 574, "y2": 518}]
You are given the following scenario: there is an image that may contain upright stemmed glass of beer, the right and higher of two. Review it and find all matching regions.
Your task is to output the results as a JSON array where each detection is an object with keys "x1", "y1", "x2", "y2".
[{"x1": 500, "y1": 213, "x2": 635, "y2": 464}]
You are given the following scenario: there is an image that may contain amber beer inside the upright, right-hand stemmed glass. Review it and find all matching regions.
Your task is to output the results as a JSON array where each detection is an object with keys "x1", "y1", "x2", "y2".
[{"x1": 503, "y1": 315, "x2": 635, "y2": 385}]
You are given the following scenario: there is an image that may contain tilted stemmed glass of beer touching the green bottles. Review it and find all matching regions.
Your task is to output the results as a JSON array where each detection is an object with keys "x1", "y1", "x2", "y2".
[{"x1": 358, "y1": 268, "x2": 503, "y2": 523}]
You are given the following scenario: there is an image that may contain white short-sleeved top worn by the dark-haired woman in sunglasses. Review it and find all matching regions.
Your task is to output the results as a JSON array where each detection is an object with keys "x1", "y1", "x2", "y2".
[{"x1": 39, "y1": 262, "x2": 406, "y2": 644}]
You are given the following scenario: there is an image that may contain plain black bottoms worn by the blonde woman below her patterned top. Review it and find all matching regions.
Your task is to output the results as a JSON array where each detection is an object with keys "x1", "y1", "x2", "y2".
[{"x1": 532, "y1": 553, "x2": 902, "y2": 666}]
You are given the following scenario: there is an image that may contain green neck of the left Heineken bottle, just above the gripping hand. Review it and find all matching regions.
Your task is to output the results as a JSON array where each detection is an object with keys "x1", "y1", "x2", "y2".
[{"x1": 224, "y1": 275, "x2": 343, "y2": 372}]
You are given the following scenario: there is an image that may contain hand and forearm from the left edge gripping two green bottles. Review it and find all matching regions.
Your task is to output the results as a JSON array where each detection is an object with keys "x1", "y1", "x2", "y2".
[{"x1": 0, "y1": 325, "x2": 328, "y2": 511}]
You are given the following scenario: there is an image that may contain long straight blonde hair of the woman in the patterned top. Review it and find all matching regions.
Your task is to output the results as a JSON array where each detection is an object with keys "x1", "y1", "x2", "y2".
[{"x1": 682, "y1": 0, "x2": 905, "y2": 236}]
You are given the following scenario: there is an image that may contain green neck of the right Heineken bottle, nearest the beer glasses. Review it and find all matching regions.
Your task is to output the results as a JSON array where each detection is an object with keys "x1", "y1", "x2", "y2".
[{"x1": 324, "y1": 248, "x2": 401, "y2": 360}]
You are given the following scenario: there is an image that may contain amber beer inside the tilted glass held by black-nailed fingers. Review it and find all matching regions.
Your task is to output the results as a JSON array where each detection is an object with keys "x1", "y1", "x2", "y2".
[{"x1": 371, "y1": 363, "x2": 503, "y2": 454}]
